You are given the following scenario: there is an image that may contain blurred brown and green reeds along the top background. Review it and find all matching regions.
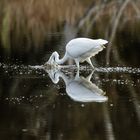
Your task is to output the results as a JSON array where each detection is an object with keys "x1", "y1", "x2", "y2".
[{"x1": 0, "y1": 0, "x2": 140, "y2": 52}]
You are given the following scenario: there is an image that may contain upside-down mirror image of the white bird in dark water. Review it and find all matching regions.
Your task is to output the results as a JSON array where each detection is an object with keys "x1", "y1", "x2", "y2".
[{"x1": 46, "y1": 69, "x2": 108, "y2": 102}]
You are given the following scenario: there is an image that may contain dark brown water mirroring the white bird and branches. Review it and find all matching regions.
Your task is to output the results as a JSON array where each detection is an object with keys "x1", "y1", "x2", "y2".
[{"x1": 0, "y1": 63, "x2": 140, "y2": 140}]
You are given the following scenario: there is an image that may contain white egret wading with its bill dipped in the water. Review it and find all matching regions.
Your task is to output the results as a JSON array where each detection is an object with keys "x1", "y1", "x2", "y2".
[{"x1": 45, "y1": 38, "x2": 108, "y2": 69}]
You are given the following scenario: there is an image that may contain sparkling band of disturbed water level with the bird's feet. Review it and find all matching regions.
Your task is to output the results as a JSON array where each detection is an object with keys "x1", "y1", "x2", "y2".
[{"x1": 0, "y1": 63, "x2": 140, "y2": 75}]
